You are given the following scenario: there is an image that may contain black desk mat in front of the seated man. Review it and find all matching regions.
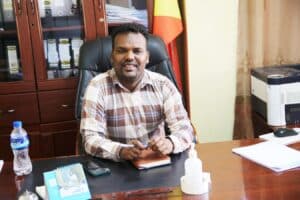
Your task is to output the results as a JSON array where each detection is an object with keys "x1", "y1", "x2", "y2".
[{"x1": 21, "y1": 152, "x2": 187, "y2": 195}]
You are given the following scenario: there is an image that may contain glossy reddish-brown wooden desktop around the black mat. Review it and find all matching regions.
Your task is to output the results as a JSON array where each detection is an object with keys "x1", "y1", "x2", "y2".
[{"x1": 0, "y1": 139, "x2": 300, "y2": 200}]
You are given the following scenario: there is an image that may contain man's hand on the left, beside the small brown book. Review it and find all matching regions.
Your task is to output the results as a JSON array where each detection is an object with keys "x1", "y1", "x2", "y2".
[{"x1": 119, "y1": 140, "x2": 144, "y2": 160}]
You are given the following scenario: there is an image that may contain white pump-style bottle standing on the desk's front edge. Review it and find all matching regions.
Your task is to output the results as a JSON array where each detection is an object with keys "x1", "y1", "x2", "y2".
[{"x1": 181, "y1": 143, "x2": 208, "y2": 195}]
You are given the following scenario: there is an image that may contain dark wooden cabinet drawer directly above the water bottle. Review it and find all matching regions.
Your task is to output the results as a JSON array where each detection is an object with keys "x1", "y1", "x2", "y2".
[{"x1": 0, "y1": 93, "x2": 39, "y2": 127}]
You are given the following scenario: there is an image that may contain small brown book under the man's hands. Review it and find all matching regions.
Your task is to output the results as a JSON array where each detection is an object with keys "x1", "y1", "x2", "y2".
[{"x1": 132, "y1": 148, "x2": 171, "y2": 169}]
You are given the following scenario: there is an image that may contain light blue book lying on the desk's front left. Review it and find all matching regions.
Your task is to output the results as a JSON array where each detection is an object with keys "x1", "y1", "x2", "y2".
[{"x1": 43, "y1": 163, "x2": 91, "y2": 200}]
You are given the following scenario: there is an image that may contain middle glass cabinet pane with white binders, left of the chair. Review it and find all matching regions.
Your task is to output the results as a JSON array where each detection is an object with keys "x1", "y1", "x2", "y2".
[{"x1": 38, "y1": 0, "x2": 84, "y2": 80}]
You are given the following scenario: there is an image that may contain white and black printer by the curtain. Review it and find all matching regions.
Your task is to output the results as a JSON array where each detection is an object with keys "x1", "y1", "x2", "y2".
[{"x1": 251, "y1": 64, "x2": 300, "y2": 126}]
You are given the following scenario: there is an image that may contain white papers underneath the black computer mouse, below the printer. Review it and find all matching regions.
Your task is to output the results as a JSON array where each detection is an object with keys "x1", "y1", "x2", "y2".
[{"x1": 259, "y1": 128, "x2": 300, "y2": 145}]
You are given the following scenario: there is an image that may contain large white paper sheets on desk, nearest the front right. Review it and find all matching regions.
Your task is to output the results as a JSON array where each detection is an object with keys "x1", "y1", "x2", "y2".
[{"x1": 232, "y1": 141, "x2": 300, "y2": 172}]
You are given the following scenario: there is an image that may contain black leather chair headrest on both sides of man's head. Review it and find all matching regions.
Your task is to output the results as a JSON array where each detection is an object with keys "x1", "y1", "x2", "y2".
[{"x1": 79, "y1": 35, "x2": 169, "y2": 73}]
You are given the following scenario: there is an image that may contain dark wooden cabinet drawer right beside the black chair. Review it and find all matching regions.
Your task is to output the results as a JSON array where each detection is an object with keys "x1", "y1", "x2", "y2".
[{"x1": 38, "y1": 90, "x2": 76, "y2": 123}]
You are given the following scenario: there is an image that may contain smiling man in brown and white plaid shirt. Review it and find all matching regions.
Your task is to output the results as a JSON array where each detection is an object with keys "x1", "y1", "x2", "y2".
[{"x1": 80, "y1": 24, "x2": 193, "y2": 161}]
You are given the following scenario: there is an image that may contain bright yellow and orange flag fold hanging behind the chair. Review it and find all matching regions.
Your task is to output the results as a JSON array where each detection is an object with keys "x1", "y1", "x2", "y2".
[{"x1": 153, "y1": 0, "x2": 183, "y2": 44}]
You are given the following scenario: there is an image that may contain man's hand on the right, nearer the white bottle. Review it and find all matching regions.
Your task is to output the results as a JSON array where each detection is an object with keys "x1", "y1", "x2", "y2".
[{"x1": 149, "y1": 136, "x2": 174, "y2": 155}]
